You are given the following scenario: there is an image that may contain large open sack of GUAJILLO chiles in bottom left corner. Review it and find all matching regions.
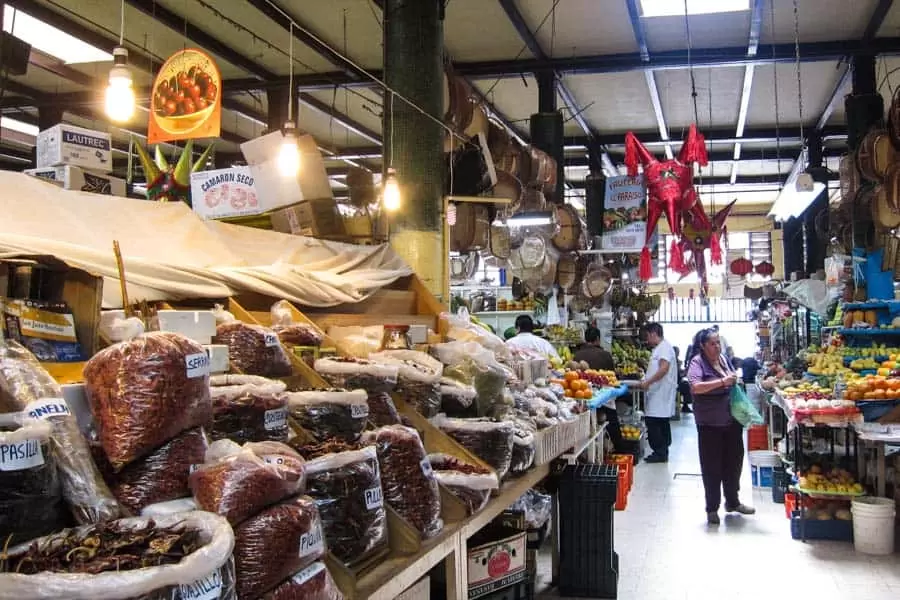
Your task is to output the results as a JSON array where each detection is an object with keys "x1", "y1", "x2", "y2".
[{"x1": 0, "y1": 511, "x2": 237, "y2": 600}]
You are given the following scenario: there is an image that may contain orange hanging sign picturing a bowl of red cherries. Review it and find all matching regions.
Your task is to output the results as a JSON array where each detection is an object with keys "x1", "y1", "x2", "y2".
[{"x1": 147, "y1": 48, "x2": 222, "y2": 144}]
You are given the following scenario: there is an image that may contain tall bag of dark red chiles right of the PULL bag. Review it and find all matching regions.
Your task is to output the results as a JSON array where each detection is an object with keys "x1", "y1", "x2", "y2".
[{"x1": 362, "y1": 425, "x2": 444, "y2": 538}]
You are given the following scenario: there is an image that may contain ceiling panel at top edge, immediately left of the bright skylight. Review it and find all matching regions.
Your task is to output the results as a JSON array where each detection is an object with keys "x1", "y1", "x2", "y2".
[{"x1": 512, "y1": 0, "x2": 637, "y2": 57}]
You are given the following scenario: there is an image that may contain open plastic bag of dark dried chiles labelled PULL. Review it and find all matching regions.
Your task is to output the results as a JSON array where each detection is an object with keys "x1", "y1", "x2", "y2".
[{"x1": 300, "y1": 441, "x2": 388, "y2": 565}]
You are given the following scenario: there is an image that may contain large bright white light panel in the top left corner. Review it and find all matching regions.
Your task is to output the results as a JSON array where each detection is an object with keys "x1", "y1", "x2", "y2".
[{"x1": 3, "y1": 4, "x2": 112, "y2": 65}]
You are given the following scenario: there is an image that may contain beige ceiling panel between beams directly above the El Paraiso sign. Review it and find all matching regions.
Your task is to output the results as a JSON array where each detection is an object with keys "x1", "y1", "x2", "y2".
[{"x1": 565, "y1": 72, "x2": 656, "y2": 135}]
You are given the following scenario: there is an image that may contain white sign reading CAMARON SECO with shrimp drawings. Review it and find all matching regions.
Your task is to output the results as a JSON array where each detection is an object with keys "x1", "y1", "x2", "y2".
[{"x1": 191, "y1": 167, "x2": 266, "y2": 219}]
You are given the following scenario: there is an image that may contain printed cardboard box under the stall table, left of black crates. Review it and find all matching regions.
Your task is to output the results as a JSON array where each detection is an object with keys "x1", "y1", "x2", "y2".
[{"x1": 467, "y1": 528, "x2": 527, "y2": 600}]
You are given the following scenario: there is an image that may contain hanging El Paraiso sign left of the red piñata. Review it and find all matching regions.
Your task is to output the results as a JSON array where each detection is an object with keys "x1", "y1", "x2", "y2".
[{"x1": 601, "y1": 174, "x2": 647, "y2": 253}]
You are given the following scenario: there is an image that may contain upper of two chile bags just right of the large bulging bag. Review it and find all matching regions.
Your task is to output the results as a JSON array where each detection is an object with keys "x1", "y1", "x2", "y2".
[{"x1": 213, "y1": 321, "x2": 293, "y2": 377}]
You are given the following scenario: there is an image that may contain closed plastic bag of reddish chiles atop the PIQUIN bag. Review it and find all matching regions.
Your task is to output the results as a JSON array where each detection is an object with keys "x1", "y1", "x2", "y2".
[{"x1": 190, "y1": 440, "x2": 306, "y2": 525}]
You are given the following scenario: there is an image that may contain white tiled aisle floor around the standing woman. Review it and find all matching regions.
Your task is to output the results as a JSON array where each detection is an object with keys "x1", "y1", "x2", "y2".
[{"x1": 537, "y1": 418, "x2": 900, "y2": 600}]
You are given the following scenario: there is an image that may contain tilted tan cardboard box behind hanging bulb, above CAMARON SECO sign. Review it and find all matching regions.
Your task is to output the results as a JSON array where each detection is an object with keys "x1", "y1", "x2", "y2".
[{"x1": 241, "y1": 131, "x2": 333, "y2": 212}]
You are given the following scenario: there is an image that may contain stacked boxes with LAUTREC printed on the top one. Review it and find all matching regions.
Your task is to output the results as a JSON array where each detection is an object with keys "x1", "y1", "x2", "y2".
[{"x1": 25, "y1": 123, "x2": 126, "y2": 196}]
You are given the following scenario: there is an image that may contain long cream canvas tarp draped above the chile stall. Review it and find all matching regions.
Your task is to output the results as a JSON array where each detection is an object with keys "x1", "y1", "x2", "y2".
[{"x1": 0, "y1": 171, "x2": 411, "y2": 307}]
